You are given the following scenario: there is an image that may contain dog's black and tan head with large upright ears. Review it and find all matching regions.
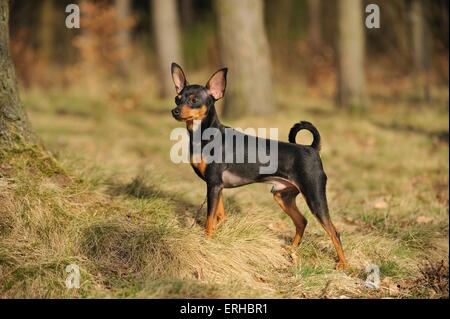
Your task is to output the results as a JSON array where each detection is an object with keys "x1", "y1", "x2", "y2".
[{"x1": 171, "y1": 63, "x2": 228, "y2": 122}]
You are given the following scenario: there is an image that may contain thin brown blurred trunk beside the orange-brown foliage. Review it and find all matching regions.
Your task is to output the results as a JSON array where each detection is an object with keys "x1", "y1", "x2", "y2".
[{"x1": 115, "y1": 0, "x2": 131, "y2": 77}]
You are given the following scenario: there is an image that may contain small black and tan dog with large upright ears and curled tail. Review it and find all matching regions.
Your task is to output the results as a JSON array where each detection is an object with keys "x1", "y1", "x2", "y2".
[{"x1": 171, "y1": 63, "x2": 346, "y2": 269}]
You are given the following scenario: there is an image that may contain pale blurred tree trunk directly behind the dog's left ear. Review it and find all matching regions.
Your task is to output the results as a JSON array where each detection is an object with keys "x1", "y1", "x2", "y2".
[{"x1": 152, "y1": 0, "x2": 183, "y2": 98}]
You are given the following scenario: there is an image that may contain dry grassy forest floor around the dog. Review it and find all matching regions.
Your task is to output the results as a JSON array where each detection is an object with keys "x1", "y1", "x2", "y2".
[{"x1": 0, "y1": 80, "x2": 449, "y2": 298}]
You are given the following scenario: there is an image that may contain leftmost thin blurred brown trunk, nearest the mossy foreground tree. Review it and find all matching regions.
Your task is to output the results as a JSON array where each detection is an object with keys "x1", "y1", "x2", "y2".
[{"x1": 39, "y1": 0, "x2": 54, "y2": 63}]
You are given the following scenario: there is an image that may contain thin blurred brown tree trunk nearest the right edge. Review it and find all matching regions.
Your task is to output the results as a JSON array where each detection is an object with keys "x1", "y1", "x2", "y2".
[{"x1": 410, "y1": 0, "x2": 430, "y2": 100}]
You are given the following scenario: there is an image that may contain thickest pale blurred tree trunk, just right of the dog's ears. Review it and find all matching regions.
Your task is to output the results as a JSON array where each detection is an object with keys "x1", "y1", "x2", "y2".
[{"x1": 216, "y1": 0, "x2": 274, "y2": 117}]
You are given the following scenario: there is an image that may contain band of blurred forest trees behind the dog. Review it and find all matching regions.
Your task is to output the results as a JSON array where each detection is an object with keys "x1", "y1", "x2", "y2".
[{"x1": 5, "y1": 0, "x2": 449, "y2": 117}]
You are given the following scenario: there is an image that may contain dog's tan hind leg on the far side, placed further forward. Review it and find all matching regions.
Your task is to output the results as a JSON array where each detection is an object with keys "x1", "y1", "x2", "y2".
[{"x1": 273, "y1": 188, "x2": 308, "y2": 247}]
